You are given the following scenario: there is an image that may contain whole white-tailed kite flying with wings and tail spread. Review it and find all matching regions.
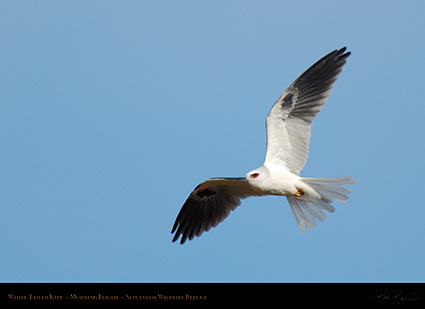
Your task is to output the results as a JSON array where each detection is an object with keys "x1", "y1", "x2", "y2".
[{"x1": 171, "y1": 47, "x2": 355, "y2": 244}]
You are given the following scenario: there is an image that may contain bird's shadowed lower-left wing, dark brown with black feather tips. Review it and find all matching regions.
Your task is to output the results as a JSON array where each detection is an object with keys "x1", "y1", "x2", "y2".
[{"x1": 171, "y1": 178, "x2": 259, "y2": 244}]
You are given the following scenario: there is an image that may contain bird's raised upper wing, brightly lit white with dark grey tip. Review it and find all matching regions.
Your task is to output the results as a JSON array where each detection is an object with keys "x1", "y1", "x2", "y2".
[{"x1": 265, "y1": 47, "x2": 350, "y2": 175}]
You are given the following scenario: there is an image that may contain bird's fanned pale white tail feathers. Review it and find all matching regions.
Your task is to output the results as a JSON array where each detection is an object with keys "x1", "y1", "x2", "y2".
[{"x1": 287, "y1": 177, "x2": 356, "y2": 232}]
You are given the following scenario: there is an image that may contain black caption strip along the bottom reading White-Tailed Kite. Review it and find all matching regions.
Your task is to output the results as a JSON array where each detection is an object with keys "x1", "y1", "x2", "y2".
[{"x1": 0, "y1": 283, "x2": 425, "y2": 308}]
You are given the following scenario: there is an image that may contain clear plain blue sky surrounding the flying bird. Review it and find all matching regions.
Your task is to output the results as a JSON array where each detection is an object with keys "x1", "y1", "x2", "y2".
[{"x1": 0, "y1": 0, "x2": 425, "y2": 282}]
